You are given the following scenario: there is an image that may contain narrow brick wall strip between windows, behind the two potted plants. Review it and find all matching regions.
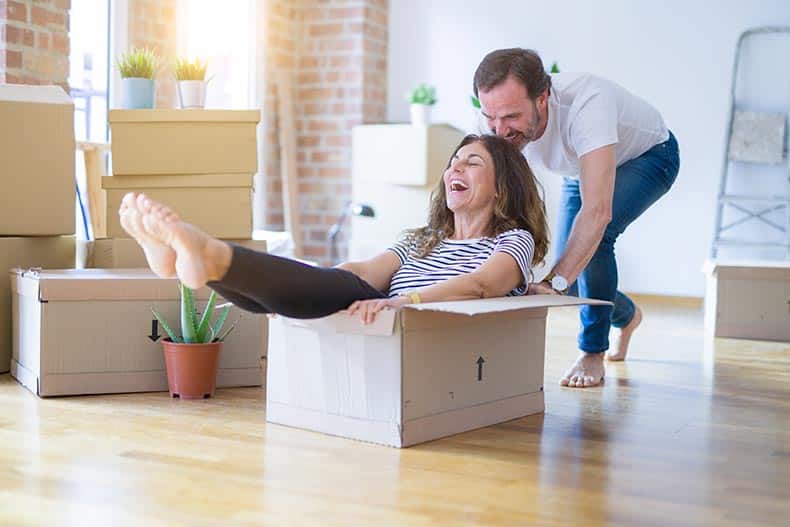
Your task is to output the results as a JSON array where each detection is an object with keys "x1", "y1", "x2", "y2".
[{"x1": 125, "y1": 0, "x2": 177, "y2": 108}]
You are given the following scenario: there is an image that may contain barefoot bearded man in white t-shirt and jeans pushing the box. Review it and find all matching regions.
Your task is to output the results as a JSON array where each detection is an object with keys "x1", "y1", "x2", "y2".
[{"x1": 474, "y1": 48, "x2": 680, "y2": 388}]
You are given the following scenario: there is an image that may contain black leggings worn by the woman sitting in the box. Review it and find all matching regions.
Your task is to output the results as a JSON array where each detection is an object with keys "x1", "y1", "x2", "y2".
[{"x1": 207, "y1": 244, "x2": 386, "y2": 318}]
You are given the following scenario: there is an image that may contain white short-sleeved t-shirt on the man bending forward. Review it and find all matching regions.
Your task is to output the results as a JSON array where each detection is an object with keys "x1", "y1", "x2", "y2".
[{"x1": 523, "y1": 73, "x2": 669, "y2": 178}]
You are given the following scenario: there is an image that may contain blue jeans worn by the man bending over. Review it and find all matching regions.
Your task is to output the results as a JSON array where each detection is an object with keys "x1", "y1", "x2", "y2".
[{"x1": 556, "y1": 132, "x2": 680, "y2": 353}]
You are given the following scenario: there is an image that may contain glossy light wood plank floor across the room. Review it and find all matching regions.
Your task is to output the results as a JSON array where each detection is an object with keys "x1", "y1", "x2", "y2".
[{"x1": 0, "y1": 303, "x2": 790, "y2": 527}]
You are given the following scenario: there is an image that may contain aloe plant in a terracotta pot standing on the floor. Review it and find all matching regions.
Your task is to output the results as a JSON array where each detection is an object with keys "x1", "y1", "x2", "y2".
[{"x1": 151, "y1": 283, "x2": 235, "y2": 399}]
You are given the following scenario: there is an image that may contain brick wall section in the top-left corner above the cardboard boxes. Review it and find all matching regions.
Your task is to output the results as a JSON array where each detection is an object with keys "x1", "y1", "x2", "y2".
[{"x1": 0, "y1": 0, "x2": 71, "y2": 90}]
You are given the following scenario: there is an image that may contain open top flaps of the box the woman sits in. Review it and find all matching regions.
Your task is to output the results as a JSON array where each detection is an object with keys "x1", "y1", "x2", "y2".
[{"x1": 283, "y1": 295, "x2": 612, "y2": 336}]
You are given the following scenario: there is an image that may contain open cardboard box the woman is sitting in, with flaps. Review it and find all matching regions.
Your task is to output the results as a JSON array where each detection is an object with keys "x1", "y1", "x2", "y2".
[{"x1": 266, "y1": 295, "x2": 607, "y2": 447}]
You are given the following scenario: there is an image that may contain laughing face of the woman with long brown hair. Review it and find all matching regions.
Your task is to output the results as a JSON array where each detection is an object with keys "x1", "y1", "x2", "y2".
[{"x1": 443, "y1": 142, "x2": 496, "y2": 214}]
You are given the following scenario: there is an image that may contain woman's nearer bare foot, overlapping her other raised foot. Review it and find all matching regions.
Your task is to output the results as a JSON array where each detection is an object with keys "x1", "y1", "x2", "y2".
[{"x1": 119, "y1": 194, "x2": 232, "y2": 289}]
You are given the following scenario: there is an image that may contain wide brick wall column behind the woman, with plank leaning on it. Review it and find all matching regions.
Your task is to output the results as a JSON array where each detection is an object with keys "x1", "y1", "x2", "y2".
[{"x1": 264, "y1": 0, "x2": 387, "y2": 264}]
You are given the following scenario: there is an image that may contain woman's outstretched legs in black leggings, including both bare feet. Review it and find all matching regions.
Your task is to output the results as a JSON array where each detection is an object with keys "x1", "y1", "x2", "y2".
[{"x1": 119, "y1": 193, "x2": 385, "y2": 318}]
